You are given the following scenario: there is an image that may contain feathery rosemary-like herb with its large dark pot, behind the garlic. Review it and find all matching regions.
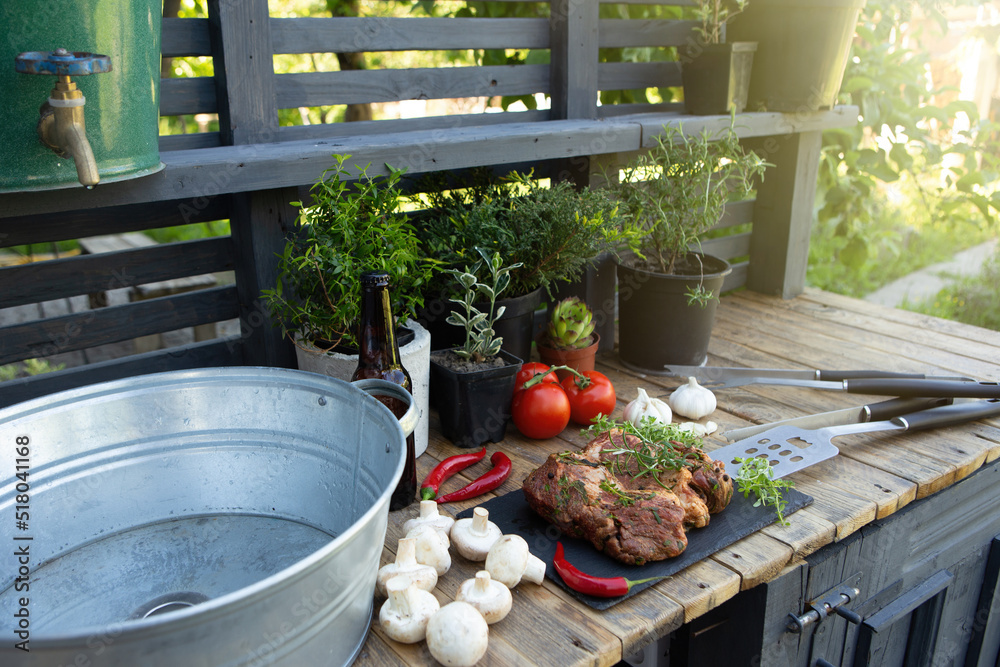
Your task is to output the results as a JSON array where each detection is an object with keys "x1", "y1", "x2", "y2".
[{"x1": 612, "y1": 118, "x2": 767, "y2": 373}]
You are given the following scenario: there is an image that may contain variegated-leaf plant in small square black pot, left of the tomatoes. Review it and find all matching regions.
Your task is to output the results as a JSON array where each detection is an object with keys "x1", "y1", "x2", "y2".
[{"x1": 430, "y1": 248, "x2": 521, "y2": 447}]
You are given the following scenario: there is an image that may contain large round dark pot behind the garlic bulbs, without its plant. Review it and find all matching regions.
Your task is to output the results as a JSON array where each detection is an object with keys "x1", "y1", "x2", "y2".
[{"x1": 618, "y1": 255, "x2": 732, "y2": 375}]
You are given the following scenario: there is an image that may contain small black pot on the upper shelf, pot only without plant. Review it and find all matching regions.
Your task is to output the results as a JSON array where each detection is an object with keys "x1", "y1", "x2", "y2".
[{"x1": 681, "y1": 42, "x2": 757, "y2": 116}]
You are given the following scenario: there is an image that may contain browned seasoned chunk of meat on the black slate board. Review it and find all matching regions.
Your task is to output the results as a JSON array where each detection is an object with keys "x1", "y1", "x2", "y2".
[{"x1": 522, "y1": 430, "x2": 733, "y2": 565}]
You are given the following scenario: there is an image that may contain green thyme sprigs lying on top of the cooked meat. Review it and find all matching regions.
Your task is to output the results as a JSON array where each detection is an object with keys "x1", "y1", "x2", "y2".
[{"x1": 584, "y1": 415, "x2": 703, "y2": 489}]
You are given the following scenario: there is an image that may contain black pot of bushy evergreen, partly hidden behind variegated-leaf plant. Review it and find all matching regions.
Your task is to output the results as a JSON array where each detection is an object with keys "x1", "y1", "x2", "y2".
[{"x1": 417, "y1": 287, "x2": 542, "y2": 359}]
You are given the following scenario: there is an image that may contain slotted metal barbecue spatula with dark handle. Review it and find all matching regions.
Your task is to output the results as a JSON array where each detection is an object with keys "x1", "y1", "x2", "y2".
[{"x1": 708, "y1": 399, "x2": 1000, "y2": 478}]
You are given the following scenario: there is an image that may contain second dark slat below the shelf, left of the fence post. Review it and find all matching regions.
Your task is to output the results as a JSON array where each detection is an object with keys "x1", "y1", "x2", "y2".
[{"x1": 0, "y1": 237, "x2": 235, "y2": 308}]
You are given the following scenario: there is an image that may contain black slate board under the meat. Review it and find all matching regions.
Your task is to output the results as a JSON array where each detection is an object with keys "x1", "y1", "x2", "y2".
[{"x1": 458, "y1": 489, "x2": 813, "y2": 609}]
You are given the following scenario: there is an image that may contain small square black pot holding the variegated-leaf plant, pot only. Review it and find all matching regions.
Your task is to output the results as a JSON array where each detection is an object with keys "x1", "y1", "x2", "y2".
[{"x1": 430, "y1": 350, "x2": 521, "y2": 447}]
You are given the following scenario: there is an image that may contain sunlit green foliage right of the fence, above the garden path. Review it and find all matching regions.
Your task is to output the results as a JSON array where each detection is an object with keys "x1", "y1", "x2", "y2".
[{"x1": 808, "y1": 0, "x2": 1000, "y2": 296}]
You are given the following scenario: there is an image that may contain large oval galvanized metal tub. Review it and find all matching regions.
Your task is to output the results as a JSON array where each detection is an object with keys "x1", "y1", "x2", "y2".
[{"x1": 0, "y1": 368, "x2": 416, "y2": 667}]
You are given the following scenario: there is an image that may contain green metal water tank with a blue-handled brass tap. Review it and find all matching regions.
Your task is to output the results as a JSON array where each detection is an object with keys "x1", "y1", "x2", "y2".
[{"x1": 0, "y1": 0, "x2": 163, "y2": 192}]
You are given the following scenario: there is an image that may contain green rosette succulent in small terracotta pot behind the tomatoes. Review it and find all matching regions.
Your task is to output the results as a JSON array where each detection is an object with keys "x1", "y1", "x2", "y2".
[{"x1": 535, "y1": 296, "x2": 600, "y2": 381}]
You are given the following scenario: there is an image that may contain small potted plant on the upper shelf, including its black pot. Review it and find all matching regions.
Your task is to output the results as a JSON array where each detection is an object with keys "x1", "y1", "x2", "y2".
[{"x1": 681, "y1": 0, "x2": 757, "y2": 115}]
